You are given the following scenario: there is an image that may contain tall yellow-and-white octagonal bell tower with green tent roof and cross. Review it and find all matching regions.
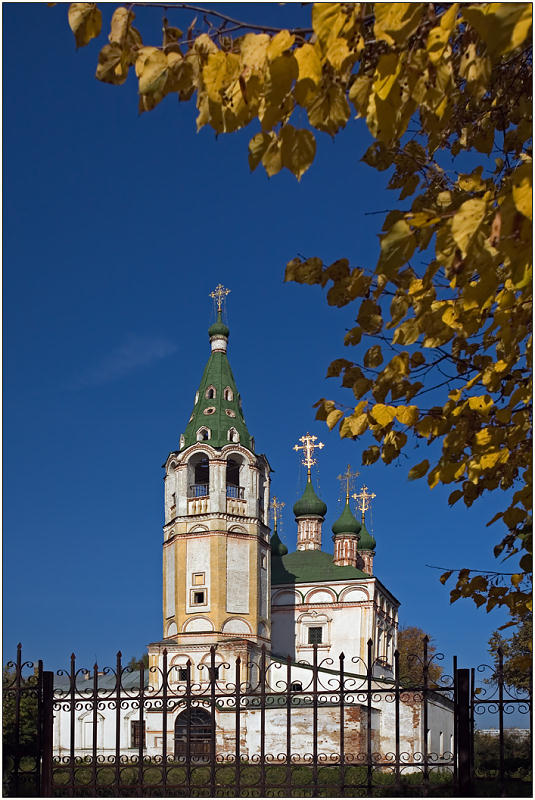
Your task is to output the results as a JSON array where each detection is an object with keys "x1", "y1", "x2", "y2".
[{"x1": 149, "y1": 284, "x2": 270, "y2": 682}]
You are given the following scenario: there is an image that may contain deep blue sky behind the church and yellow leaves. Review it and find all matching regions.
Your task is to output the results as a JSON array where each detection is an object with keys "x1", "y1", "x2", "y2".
[{"x1": 3, "y1": 3, "x2": 524, "y2": 724}]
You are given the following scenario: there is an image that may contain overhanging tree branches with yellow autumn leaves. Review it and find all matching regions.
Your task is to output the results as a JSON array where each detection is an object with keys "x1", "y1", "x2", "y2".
[{"x1": 69, "y1": 3, "x2": 532, "y2": 615}]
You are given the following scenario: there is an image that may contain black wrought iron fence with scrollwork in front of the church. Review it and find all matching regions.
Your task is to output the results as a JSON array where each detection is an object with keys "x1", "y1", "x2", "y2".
[{"x1": 4, "y1": 640, "x2": 531, "y2": 797}]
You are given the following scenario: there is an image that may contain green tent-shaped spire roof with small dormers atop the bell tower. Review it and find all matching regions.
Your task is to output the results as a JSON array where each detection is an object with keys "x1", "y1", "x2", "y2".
[{"x1": 181, "y1": 312, "x2": 253, "y2": 450}]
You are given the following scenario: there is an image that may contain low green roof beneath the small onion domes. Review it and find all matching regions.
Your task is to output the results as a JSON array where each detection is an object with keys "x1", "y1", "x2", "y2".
[{"x1": 271, "y1": 550, "x2": 370, "y2": 586}]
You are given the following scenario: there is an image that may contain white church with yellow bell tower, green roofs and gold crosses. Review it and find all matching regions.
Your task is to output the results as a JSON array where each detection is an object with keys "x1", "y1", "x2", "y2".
[{"x1": 55, "y1": 285, "x2": 453, "y2": 758}]
